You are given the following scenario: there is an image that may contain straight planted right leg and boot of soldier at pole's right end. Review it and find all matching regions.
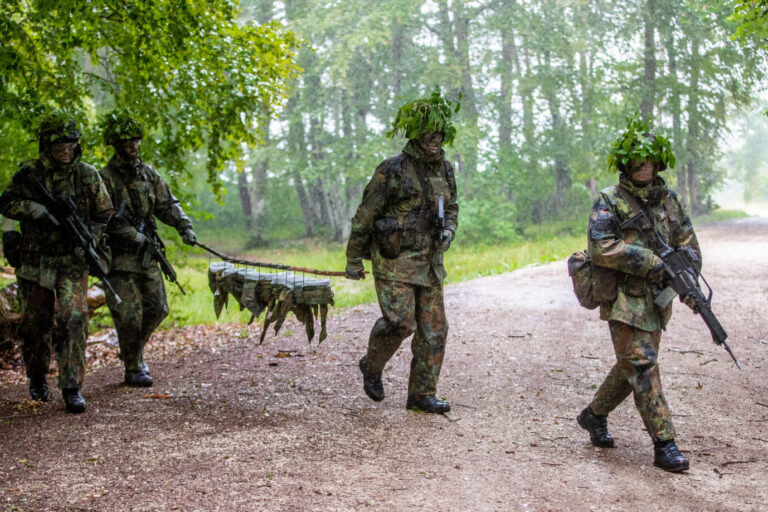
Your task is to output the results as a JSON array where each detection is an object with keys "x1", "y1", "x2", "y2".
[{"x1": 406, "y1": 284, "x2": 451, "y2": 413}]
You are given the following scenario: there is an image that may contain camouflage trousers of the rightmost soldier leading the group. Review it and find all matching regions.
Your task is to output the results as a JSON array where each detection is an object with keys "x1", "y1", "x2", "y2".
[{"x1": 590, "y1": 320, "x2": 675, "y2": 441}]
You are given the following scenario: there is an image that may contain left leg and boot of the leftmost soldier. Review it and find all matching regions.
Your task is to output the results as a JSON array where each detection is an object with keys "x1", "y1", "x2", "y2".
[{"x1": 19, "y1": 279, "x2": 55, "y2": 401}]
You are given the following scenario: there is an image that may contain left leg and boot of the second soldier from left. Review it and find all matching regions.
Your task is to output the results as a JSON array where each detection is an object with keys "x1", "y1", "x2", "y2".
[{"x1": 107, "y1": 272, "x2": 152, "y2": 386}]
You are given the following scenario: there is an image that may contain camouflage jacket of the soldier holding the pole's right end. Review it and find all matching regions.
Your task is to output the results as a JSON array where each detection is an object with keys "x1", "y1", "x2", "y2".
[{"x1": 347, "y1": 142, "x2": 459, "y2": 286}]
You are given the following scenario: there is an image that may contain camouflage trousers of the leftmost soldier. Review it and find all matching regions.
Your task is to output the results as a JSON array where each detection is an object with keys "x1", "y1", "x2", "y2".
[{"x1": 19, "y1": 270, "x2": 88, "y2": 389}]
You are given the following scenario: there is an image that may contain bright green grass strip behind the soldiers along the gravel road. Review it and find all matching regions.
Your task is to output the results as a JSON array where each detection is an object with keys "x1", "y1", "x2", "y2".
[{"x1": 163, "y1": 235, "x2": 585, "y2": 327}]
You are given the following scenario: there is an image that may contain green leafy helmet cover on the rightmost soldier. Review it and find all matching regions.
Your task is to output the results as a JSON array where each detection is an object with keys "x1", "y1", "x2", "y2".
[{"x1": 608, "y1": 113, "x2": 675, "y2": 172}]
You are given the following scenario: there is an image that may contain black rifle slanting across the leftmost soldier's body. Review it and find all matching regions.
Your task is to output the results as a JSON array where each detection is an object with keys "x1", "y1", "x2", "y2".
[{"x1": 29, "y1": 174, "x2": 122, "y2": 304}]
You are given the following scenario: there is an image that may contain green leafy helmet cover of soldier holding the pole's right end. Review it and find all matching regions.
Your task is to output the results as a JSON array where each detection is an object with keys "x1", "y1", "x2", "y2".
[{"x1": 386, "y1": 86, "x2": 461, "y2": 146}]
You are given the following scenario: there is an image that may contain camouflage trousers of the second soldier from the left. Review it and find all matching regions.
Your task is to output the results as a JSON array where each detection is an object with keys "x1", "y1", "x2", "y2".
[{"x1": 107, "y1": 265, "x2": 168, "y2": 371}]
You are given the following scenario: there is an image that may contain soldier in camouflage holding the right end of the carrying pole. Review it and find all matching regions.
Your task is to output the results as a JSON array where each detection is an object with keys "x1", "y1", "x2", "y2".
[{"x1": 346, "y1": 90, "x2": 459, "y2": 413}]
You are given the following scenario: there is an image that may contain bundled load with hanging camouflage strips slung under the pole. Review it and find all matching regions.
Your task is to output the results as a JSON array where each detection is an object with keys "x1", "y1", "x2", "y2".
[{"x1": 208, "y1": 262, "x2": 333, "y2": 343}]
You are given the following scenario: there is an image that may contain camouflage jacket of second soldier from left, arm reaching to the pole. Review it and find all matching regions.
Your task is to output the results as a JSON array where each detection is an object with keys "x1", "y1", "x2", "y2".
[{"x1": 99, "y1": 155, "x2": 192, "y2": 273}]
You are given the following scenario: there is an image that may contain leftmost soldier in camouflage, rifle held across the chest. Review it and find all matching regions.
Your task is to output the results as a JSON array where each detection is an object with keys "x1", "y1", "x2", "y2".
[{"x1": 0, "y1": 112, "x2": 114, "y2": 413}]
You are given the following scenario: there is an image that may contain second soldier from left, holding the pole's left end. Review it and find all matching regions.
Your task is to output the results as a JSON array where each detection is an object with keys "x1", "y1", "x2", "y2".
[{"x1": 100, "y1": 113, "x2": 197, "y2": 387}]
